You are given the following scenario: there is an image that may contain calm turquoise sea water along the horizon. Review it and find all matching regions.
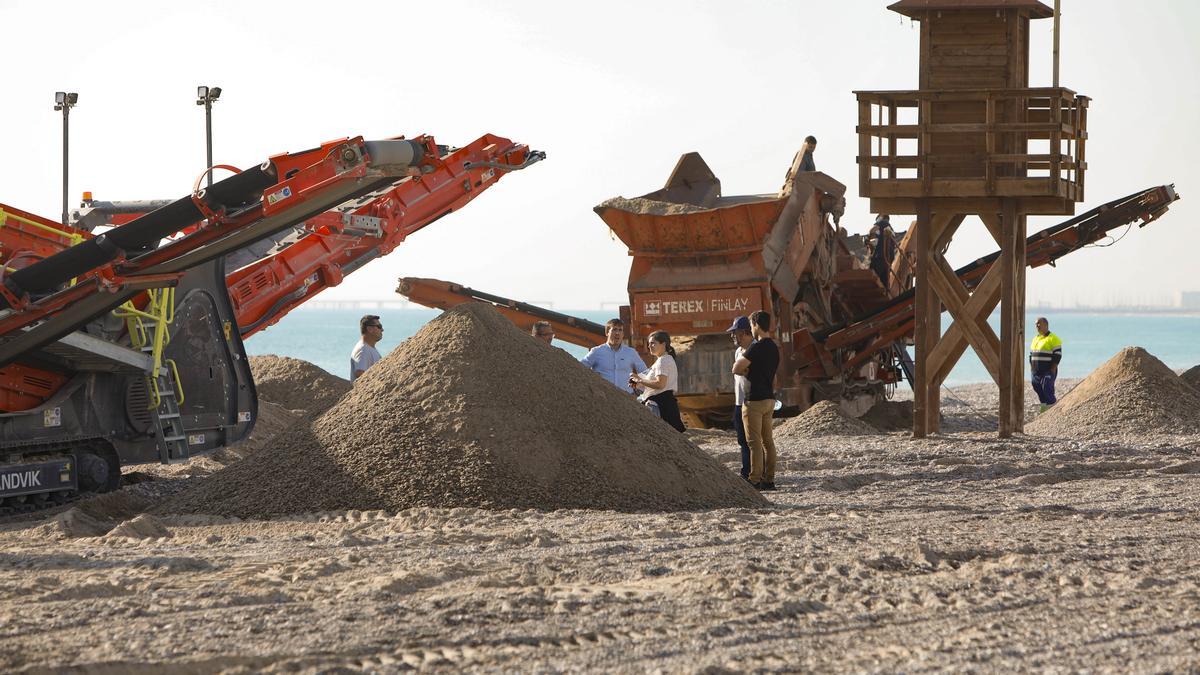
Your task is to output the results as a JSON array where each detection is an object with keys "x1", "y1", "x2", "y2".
[{"x1": 246, "y1": 309, "x2": 1200, "y2": 386}]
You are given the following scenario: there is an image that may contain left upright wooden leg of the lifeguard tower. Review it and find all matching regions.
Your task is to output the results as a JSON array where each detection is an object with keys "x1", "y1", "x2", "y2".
[{"x1": 912, "y1": 199, "x2": 938, "y2": 438}]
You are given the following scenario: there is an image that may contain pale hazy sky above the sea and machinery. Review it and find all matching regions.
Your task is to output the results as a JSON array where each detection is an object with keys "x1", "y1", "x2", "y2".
[{"x1": 0, "y1": 0, "x2": 1200, "y2": 309}]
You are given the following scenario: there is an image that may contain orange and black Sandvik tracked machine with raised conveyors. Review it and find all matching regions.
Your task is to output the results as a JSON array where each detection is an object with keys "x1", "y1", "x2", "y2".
[{"x1": 0, "y1": 135, "x2": 545, "y2": 514}]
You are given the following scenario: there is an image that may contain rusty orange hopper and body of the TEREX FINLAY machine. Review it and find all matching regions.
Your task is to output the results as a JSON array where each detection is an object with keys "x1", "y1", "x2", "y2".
[{"x1": 595, "y1": 153, "x2": 892, "y2": 424}]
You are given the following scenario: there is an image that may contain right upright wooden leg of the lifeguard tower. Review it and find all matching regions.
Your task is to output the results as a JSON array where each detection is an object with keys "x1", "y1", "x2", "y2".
[{"x1": 1000, "y1": 199, "x2": 1025, "y2": 438}]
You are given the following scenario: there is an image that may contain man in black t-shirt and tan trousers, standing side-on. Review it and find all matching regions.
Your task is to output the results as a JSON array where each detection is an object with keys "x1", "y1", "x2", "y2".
[{"x1": 733, "y1": 311, "x2": 779, "y2": 490}]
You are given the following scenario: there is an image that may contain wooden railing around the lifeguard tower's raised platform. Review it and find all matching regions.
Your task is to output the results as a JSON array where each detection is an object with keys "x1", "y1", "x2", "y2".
[{"x1": 856, "y1": 88, "x2": 1088, "y2": 202}]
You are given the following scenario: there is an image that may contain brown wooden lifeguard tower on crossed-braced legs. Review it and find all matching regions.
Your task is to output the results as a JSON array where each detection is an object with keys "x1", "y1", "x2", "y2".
[{"x1": 856, "y1": 0, "x2": 1087, "y2": 437}]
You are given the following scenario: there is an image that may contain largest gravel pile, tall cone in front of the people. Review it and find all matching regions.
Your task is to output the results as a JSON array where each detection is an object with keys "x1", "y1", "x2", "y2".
[{"x1": 160, "y1": 303, "x2": 767, "y2": 518}]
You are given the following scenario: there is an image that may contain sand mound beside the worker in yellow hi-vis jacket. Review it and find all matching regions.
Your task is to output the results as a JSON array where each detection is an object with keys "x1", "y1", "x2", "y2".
[{"x1": 1026, "y1": 347, "x2": 1200, "y2": 438}]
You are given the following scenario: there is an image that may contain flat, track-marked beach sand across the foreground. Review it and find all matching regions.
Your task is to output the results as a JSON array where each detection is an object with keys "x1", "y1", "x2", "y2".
[{"x1": 0, "y1": 372, "x2": 1200, "y2": 673}]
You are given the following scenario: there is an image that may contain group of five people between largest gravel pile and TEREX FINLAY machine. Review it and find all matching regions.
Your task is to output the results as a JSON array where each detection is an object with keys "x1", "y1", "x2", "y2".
[{"x1": 576, "y1": 311, "x2": 780, "y2": 490}]
